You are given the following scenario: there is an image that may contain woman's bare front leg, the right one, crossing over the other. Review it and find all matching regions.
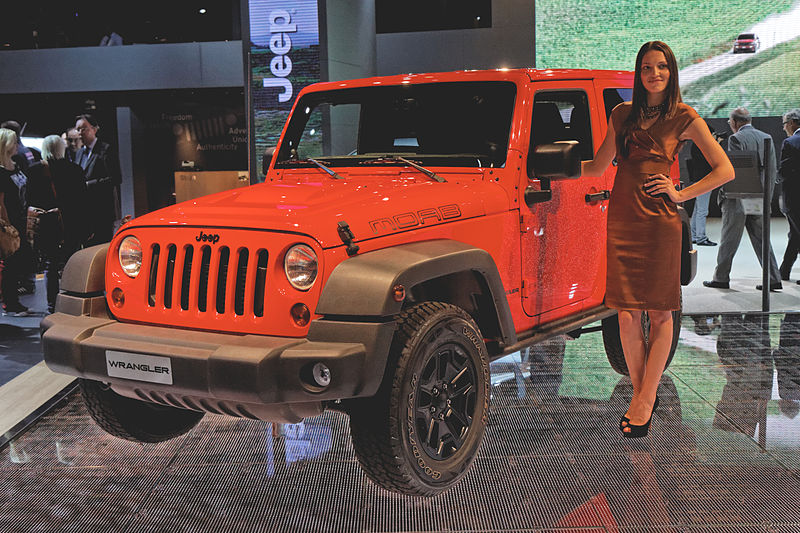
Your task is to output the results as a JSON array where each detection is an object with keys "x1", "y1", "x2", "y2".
[{"x1": 628, "y1": 311, "x2": 672, "y2": 426}]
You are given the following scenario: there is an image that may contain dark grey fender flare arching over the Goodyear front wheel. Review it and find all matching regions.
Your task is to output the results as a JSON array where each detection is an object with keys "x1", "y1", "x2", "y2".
[{"x1": 316, "y1": 239, "x2": 517, "y2": 346}]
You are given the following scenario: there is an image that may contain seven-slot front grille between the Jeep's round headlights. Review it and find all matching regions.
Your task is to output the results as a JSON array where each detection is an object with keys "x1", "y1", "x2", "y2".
[{"x1": 147, "y1": 243, "x2": 268, "y2": 317}]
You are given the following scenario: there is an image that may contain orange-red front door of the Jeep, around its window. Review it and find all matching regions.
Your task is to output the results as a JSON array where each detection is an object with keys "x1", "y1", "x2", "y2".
[{"x1": 520, "y1": 80, "x2": 608, "y2": 321}]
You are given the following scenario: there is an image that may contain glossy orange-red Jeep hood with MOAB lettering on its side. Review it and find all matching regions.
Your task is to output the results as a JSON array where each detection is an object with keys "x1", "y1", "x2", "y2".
[{"x1": 127, "y1": 169, "x2": 508, "y2": 248}]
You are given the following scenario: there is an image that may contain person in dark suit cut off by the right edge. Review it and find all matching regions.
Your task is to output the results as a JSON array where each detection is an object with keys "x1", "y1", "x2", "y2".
[{"x1": 778, "y1": 108, "x2": 800, "y2": 283}]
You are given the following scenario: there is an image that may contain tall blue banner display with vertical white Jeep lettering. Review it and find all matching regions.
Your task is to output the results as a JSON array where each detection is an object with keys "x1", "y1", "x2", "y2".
[{"x1": 248, "y1": 0, "x2": 320, "y2": 182}]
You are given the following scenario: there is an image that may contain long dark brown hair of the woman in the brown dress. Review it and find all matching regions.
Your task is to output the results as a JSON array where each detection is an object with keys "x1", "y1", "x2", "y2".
[{"x1": 617, "y1": 41, "x2": 683, "y2": 157}]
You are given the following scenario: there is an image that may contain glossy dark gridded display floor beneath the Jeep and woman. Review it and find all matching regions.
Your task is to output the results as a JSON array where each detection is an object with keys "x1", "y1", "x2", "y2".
[{"x1": 0, "y1": 314, "x2": 800, "y2": 532}]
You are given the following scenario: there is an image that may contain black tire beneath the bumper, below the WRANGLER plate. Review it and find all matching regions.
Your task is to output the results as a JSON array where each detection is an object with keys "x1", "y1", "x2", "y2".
[{"x1": 78, "y1": 379, "x2": 204, "y2": 443}]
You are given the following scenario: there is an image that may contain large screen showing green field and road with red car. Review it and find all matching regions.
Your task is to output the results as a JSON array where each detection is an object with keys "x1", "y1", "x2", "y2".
[{"x1": 535, "y1": 0, "x2": 800, "y2": 118}]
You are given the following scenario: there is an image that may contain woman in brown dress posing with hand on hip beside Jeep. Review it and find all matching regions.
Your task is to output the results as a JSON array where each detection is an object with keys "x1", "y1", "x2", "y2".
[{"x1": 582, "y1": 41, "x2": 733, "y2": 437}]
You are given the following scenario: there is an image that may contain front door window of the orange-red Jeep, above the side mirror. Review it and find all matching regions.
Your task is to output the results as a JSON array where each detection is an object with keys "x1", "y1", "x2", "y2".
[{"x1": 531, "y1": 89, "x2": 594, "y2": 160}]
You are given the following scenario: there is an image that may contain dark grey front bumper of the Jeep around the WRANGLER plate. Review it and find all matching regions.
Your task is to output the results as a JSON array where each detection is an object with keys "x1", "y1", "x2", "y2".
[{"x1": 41, "y1": 294, "x2": 395, "y2": 421}]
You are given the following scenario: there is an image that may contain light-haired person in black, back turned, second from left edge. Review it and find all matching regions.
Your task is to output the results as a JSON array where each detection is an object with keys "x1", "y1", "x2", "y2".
[{"x1": 27, "y1": 135, "x2": 88, "y2": 313}]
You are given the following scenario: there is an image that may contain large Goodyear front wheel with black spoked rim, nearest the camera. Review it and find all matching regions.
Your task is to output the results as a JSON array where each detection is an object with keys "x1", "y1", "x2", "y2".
[{"x1": 349, "y1": 302, "x2": 489, "y2": 496}]
